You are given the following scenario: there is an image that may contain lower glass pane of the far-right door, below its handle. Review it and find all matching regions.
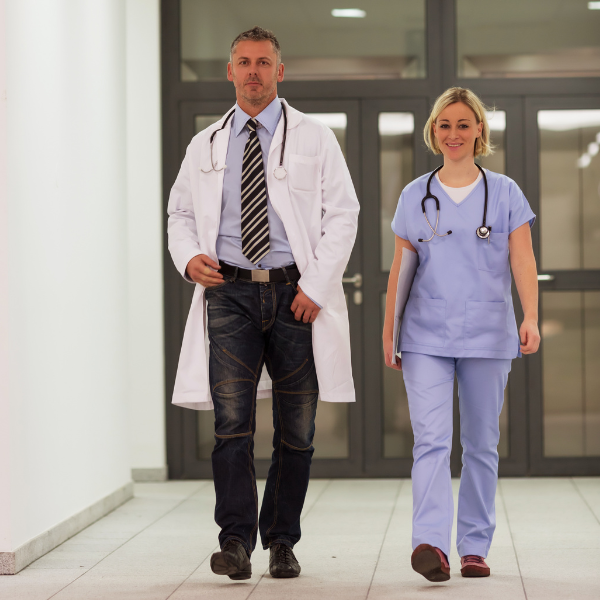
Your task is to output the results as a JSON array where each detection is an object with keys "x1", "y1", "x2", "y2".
[{"x1": 541, "y1": 292, "x2": 600, "y2": 456}]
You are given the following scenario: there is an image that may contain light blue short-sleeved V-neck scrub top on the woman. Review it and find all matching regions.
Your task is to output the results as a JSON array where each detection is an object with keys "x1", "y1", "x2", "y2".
[{"x1": 392, "y1": 170, "x2": 535, "y2": 358}]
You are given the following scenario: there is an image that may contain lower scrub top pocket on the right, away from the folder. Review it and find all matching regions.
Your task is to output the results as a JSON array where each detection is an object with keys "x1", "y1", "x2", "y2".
[{"x1": 465, "y1": 302, "x2": 508, "y2": 350}]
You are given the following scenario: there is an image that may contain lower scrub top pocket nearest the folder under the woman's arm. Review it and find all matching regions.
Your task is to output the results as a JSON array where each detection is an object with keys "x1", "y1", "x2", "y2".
[{"x1": 401, "y1": 297, "x2": 446, "y2": 348}]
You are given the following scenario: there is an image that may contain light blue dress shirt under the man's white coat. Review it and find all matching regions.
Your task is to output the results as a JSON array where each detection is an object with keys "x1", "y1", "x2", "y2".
[{"x1": 217, "y1": 96, "x2": 294, "y2": 269}]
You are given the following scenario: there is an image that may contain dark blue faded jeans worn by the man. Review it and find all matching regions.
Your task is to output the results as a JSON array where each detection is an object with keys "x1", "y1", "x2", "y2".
[{"x1": 205, "y1": 278, "x2": 318, "y2": 554}]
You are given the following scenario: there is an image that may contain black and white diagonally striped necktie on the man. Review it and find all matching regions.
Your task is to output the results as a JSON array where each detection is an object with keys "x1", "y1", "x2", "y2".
[{"x1": 242, "y1": 119, "x2": 270, "y2": 264}]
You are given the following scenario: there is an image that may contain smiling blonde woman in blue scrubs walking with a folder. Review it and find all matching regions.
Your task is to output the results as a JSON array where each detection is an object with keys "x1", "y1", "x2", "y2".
[{"x1": 383, "y1": 88, "x2": 540, "y2": 581}]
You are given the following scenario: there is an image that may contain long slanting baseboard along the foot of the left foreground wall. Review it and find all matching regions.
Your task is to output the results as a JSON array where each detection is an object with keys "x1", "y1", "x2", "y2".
[{"x1": 0, "y1": 482, "x2": 133, "y2": 575}]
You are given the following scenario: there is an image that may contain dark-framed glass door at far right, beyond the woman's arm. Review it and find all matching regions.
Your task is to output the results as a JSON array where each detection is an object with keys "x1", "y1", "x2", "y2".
[{"x1": 527, "y1": 97, "x2": 600, "y2": 475}]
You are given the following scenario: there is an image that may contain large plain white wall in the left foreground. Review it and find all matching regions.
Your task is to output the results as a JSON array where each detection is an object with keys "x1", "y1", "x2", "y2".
[{"x1": 0, "y1": 0, "x2": 130, "y2": 551}]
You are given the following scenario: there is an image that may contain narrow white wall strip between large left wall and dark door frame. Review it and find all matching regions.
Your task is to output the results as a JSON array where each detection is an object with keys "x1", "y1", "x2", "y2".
[{"x1": 126, "y1": 0, "x2": 166, "y2": 472}]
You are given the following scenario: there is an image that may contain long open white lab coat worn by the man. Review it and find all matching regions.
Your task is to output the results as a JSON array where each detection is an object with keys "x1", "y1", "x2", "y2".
[{"x1": 168, "y1": 100, "x2": 359, "y2": 410}]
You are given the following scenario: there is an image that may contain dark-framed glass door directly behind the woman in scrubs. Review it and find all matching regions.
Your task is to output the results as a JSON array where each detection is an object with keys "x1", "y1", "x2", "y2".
[{"x1": 362, "y1": 99, "x2": 526, "y2": 477}]
